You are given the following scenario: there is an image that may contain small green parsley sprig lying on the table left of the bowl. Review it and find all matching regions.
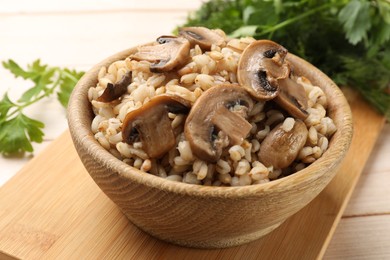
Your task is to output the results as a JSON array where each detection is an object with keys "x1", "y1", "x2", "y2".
[{"x1": 0, "y1": 60, "x2": 84, "y2": 155}]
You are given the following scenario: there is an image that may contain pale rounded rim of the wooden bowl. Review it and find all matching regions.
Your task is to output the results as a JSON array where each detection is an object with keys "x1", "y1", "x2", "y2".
[{"x1": 67, "y1": 47, "x2": 353, "y2": 199}]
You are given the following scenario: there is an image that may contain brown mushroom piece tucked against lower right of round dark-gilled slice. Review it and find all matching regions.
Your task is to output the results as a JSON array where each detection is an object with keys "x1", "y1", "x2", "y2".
[{"x1": 274, "y1": 75, "x2": 309, "y2": 120}]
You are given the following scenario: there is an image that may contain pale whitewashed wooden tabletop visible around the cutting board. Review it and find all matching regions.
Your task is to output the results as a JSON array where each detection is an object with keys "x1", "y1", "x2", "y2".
[{"x1": 0, "y1": 0, "x2": 390, "y2": 259}]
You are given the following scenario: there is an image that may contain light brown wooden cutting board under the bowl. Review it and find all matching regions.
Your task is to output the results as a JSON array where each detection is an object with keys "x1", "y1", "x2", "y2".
[{"x1": 0, "y1": 89, "x2": 385, "y2": 259}]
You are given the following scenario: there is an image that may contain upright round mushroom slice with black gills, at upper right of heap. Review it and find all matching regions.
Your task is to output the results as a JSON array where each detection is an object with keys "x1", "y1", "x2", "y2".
[{"x1": 237, "y1": 40, "x2": 290, "y2": 100}]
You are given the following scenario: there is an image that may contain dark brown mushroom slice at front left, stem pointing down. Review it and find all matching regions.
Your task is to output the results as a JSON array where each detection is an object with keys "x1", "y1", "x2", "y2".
[{"x1": 122, "y1": 95, "x2": 191, "y2": 158}]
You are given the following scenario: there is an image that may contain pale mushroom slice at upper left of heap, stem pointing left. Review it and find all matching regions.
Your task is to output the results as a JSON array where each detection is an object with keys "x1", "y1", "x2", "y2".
[{"x1": 130, "y1": 36, "x2": 190, "y2": 72}]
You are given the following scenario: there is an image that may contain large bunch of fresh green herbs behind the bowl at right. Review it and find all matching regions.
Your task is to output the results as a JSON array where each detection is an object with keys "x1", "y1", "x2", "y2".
[{"x1": 185, "y1": 0, "x2": 390, "y2": 119}]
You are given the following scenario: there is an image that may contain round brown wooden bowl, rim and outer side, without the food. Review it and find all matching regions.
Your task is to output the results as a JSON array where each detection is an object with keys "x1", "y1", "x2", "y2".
[{"x1": 68, "y1": 48, "x2": 352, "y2": 248}]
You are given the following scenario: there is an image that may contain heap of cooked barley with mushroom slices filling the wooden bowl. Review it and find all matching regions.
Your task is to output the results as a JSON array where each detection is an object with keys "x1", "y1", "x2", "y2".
[{"x1": 88, "y1": 27, "x2": 336, "y2": 186}]
